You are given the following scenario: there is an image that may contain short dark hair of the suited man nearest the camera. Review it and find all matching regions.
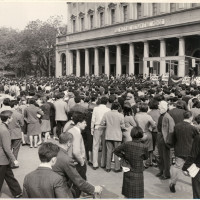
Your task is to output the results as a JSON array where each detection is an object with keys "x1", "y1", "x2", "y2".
[{"x1": 38, "y1": 142, "x2": 60, "y2": 163}]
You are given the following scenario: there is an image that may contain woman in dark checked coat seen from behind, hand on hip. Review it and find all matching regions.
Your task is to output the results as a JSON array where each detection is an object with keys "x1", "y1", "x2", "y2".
[{"x1": 114, "y1": 126, "x2": 148, "y2": 198}]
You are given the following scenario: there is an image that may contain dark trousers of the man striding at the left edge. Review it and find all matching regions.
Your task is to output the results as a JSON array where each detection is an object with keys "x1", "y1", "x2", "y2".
[{"x1": 0, "y1": 165, "x2": 22, "y2": 197}]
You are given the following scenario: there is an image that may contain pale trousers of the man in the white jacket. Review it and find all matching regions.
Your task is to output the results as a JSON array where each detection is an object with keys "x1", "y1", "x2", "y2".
[{"x1": 92, "y1": 129, "x2": 106, "y2": 167}]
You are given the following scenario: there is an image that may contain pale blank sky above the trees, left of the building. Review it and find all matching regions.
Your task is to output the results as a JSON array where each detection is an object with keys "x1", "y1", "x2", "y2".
[{"x1": 0, "y1": 0, "x2": 67, "y2": 30}]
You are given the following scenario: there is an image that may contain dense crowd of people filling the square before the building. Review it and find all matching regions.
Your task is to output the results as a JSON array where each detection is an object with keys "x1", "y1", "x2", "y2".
[{"x1": 0, "y1": 75, "x2": 200, "y2": 198}]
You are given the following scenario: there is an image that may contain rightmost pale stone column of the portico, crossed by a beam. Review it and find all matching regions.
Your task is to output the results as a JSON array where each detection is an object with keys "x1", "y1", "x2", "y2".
[{"x1": 178, "y1": 37, "x2": 185, "y2": 77}]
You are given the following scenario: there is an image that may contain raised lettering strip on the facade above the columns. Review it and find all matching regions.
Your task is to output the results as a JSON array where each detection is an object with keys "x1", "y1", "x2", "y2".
[{"x1": 115, "y1": 19, "x2": 165, "y2": 33}]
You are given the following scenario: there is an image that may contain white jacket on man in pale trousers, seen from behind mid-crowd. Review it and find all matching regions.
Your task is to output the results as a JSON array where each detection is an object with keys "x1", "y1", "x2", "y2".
[{"x1": 91, "y1": 104, "x2": 110, "y2": 129}]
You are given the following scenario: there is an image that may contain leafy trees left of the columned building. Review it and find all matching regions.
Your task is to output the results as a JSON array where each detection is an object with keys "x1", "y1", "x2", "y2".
[{"x1": 0, "y1": 16, "x2": 66, "y2": 75}]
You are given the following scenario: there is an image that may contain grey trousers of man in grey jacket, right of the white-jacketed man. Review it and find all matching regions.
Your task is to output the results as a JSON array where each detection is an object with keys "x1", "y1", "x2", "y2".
[{"x1": 106, "y1": 140, "x2": 121, "y2": 170}]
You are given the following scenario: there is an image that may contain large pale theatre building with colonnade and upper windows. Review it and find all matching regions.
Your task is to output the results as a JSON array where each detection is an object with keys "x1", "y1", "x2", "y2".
[{"x1": 56, "y1": 2, "x2": 200, "y2": 77}]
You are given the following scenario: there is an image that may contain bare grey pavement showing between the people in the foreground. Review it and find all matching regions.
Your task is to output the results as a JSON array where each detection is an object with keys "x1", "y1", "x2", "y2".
[{"x1": 1, "y1": 139, "x2": 192, "y2": 199}]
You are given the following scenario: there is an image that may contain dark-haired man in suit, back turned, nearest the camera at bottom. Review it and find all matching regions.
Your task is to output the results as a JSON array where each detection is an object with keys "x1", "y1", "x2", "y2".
[{"x1": 23, "y1": 142, "x2": 72, "y2": 198}]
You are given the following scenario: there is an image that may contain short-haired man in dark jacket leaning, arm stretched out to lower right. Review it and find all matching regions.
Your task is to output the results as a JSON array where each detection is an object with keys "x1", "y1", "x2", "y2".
[{"x1": 53, "y1": 132, "x2": 102, "y2": 198}]
